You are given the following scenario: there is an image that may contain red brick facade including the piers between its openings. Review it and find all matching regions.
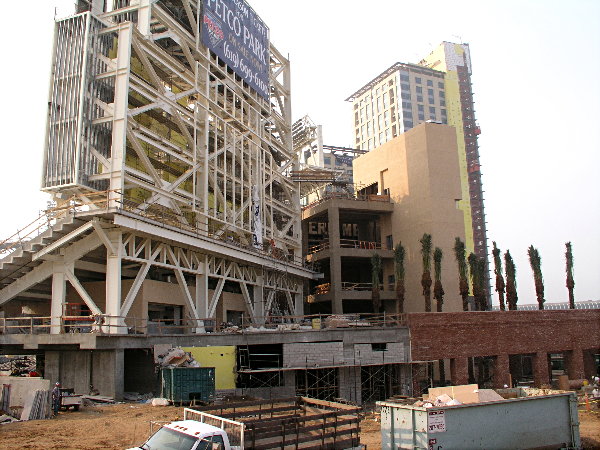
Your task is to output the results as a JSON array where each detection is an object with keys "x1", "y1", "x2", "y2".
[{"x1": 408, "y1": 310, "x2": 600, "y2": 387}]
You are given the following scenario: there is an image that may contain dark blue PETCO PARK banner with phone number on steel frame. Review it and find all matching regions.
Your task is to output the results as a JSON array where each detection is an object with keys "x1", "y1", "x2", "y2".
[{"x1": 202, "y1": 0, "x2": 270, "y2": 99}]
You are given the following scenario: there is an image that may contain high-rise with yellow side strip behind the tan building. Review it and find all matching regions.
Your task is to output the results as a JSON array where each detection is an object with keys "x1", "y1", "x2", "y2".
[{"x1": 347, "y1": 42, "x2": 489, "y2": 302}]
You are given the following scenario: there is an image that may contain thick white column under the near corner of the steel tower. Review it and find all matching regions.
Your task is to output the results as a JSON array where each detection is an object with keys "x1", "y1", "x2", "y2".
[{"x1": 104, "y1": 231, "x2": 127, "y2": 334}]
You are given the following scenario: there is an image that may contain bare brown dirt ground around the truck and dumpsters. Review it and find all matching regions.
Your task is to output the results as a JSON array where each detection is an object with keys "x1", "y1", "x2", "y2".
[{"x1": 0, "y1": 403, "x2": 600, "y2": 450}]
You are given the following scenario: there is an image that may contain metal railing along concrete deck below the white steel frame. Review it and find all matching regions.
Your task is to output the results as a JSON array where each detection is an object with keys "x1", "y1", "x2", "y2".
[{"x1": 0, "y1": 313, "x2": 406, "y2": 336}]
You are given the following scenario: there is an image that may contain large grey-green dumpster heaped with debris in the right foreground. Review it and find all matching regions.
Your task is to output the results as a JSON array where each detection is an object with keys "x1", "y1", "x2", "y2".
[{"x1": 377, "y1": 389, "x2": 581, "y2": 450}]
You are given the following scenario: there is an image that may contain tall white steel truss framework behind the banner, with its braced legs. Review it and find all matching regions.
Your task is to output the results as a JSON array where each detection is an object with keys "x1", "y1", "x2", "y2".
[{"x1": 0, "y1": 0, "x2": 311, "y2": 332}]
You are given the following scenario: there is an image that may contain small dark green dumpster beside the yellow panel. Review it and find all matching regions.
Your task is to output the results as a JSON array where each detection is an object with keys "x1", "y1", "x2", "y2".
[{"x1": 161, "y1": 367, "x2": 215, "y2": 404}]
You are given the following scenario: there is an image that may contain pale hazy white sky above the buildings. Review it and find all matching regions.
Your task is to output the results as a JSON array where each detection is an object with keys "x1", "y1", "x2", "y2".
[{"x1": 0, "y1": 0, "x2": 600, "y2": 304}]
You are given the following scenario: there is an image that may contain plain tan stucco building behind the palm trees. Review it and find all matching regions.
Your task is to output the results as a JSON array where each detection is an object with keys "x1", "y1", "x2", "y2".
[{"x1": 354, "y1": 123, "x2": 465, "y2": 312}]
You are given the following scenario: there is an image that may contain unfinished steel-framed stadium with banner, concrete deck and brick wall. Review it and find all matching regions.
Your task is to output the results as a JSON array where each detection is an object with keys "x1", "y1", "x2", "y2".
[{"x1": 0, "y1": 0, "x2": 600, "y2": 403}]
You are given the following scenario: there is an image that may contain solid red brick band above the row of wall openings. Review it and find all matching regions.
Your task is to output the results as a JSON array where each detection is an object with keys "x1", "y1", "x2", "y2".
[{"x1": 408, "y1": 310, "x2": 600, "y2": 361}]
